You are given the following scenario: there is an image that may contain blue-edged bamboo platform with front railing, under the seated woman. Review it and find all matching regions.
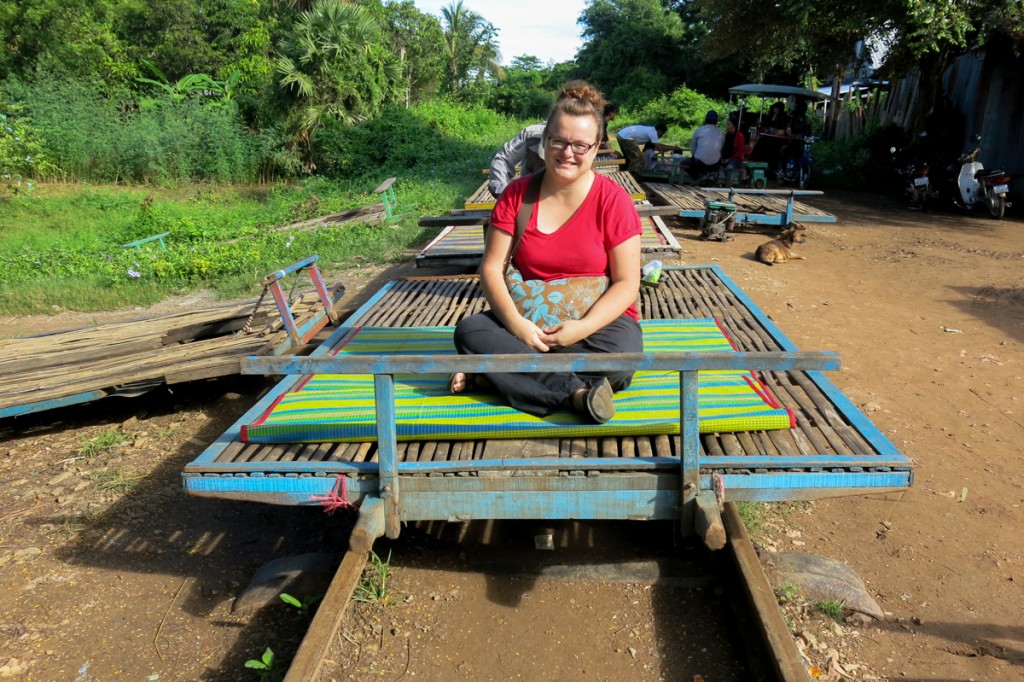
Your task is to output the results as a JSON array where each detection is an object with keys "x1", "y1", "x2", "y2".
[{"x1": 182, "y1": 265, "x2": 913, "y2": 536}]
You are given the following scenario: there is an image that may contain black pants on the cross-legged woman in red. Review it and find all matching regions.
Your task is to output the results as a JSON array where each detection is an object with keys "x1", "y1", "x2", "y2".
[{"x1": 455, "y1": 310, "x2": 643, "y2": 417}]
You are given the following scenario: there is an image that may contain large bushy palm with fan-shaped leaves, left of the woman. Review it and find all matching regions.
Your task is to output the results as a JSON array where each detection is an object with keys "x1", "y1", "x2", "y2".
[{"x1": 275, "y1": 0, "x2": 401, "y2": 159}]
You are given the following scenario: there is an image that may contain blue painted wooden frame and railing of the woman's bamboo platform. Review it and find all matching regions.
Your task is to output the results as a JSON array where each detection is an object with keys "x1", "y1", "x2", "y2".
[{"x1": 182, "y1": 265, "x2": 912, "y2": 522}]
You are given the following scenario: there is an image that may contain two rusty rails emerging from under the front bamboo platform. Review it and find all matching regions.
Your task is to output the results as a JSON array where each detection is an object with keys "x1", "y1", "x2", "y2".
[{"x1": 284, "y1": 503, "x2": 809, "y2": 682}]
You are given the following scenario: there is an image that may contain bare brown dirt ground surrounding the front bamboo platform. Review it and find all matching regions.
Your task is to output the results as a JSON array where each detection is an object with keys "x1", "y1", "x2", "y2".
[{"x1": 0, "y1": 187, "x2": 1024, "y2": 682}]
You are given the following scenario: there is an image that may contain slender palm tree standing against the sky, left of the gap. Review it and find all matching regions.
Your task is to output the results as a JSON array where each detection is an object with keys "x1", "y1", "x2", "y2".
[{"x1": 441, "y1": 0, "x2": 505, "y2": 92}]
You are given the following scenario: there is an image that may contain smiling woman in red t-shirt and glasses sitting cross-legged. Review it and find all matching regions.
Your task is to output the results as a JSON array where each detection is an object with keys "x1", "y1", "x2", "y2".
[{"x1": 450, "y1": 81, "x2": 643, "y2": 423}]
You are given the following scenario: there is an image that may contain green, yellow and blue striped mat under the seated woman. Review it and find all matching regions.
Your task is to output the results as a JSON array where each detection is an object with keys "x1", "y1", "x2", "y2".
[{"x1": 242, "y1": 319, "x2": 793, "y2": 443}]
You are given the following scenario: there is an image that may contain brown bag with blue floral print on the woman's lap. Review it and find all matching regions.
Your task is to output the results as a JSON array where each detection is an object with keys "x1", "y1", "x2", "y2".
[{"x1": 505, "y1": 266, "x2": 608, "y2": 327}]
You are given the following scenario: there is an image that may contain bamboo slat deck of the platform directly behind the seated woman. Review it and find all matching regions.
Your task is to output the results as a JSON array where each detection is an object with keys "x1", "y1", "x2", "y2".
[{"x1": 416, "y1": 216, "x2": 682, "y2": 267}]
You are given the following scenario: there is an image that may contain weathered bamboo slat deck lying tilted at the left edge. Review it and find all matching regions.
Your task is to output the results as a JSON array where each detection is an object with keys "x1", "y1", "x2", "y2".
[{"x1": 0, "y1": 284, "x2": 346, "y2": 417}]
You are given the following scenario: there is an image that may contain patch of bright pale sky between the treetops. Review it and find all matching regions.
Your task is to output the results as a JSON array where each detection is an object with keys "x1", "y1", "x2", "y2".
[{"x1": 407, "y1": 0, "x2": 587, "y2": 67}]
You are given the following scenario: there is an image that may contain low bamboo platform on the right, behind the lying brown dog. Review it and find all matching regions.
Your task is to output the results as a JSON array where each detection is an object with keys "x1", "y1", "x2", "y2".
[{"x1": 643, "y1": 182, "x2": 836, "y2": 227}]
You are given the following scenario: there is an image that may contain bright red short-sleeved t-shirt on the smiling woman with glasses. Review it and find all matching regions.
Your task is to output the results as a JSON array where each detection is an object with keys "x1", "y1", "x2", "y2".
[{"x1": 490, "y1": 173, "x2": 641, "y2": 319}]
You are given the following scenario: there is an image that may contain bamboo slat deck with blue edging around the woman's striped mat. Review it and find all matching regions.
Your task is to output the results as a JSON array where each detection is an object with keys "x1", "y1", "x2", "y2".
[{"x1": 183, "y1": 266, "x2": 912, "y2": 507}]
